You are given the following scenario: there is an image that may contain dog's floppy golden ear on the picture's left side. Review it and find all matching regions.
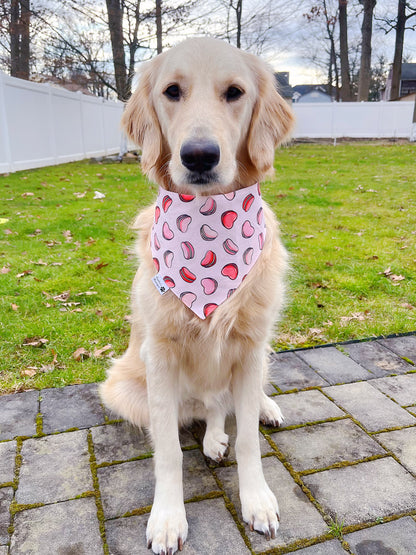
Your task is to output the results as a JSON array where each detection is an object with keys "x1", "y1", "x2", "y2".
[{"x1": 121, "y1": 60, "x2": 162, "y2": 174}]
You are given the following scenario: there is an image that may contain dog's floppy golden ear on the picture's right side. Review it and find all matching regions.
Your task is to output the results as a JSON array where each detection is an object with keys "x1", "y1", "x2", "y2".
[{"x1": 247, "y1": 56, "x2": 294, "y2": 174}]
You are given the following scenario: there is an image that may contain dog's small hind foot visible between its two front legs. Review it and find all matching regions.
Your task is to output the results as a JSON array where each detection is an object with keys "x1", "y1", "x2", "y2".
[{"x1": 202, "y1": 402, "x2": 229, "y2": 462}]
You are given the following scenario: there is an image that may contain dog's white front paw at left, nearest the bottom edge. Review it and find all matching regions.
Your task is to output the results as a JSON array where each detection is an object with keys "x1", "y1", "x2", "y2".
[{"x1": 146, "y1": 505, "x2": 188, "y2": 555}]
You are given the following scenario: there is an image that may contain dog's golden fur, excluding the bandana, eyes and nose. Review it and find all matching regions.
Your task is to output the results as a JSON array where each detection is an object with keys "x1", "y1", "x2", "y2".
[{"x1": 101, "y1": 39, "x2": 292, "y2": 553}]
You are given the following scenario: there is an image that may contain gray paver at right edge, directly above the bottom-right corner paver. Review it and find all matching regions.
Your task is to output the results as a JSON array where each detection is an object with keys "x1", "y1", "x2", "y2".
[{"x1": 302, "y1": 457, "x2": 416, "y2": 525}]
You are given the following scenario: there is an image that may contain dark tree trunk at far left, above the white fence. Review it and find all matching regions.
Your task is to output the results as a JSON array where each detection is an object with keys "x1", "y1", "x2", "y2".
[{"x1": 10, "y1": 0, "x2": 30, "y2": 79}]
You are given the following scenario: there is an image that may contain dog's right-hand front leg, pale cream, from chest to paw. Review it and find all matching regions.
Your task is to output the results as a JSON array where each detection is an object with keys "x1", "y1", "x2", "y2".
[{"x1": 232, "y1": 353, "x2": 279, "y2": 539}]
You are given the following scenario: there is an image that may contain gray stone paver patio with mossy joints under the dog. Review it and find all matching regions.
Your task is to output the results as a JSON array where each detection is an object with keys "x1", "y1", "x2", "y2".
[{"x1": 0, "y1": 334, "x2": 416, "y2": 555}]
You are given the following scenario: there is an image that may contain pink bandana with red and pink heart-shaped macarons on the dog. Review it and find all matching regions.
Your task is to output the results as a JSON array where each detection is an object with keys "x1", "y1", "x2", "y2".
[{"x1": 151, "y1": 184, "x2": 266, "y2": 319}]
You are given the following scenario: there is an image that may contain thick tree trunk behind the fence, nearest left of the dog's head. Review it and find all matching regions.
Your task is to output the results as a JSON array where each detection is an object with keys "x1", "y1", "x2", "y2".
[{"x1": 106, "y1": 0, "x2": 130, "y2": 101}]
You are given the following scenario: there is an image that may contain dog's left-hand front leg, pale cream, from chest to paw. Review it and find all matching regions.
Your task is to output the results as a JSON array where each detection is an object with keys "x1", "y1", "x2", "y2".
[{"x1": 146, "y1": 350, "x2": 188, "y2": 555}]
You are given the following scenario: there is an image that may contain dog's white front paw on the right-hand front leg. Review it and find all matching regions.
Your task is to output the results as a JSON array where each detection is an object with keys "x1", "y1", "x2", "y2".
[{"x1": 240, "y1": 484, "x2": 280, "y2": 540}]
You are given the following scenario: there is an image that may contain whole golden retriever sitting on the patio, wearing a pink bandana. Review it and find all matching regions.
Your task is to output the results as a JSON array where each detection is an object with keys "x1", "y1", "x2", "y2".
[{"x1": 100, "y1": 38, "x2": 293, "y2": 555}]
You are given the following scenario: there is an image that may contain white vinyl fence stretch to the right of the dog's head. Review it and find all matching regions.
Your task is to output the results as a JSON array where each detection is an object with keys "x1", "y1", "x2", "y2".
[{"x1": 293, "y1": 102, "x2": 414, "y2": 139}]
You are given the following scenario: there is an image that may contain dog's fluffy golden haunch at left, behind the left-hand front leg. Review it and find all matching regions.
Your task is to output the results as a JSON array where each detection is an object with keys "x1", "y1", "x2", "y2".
[{"x1": 99, "y1": 325, "x2": 149, "y2": 427}]
